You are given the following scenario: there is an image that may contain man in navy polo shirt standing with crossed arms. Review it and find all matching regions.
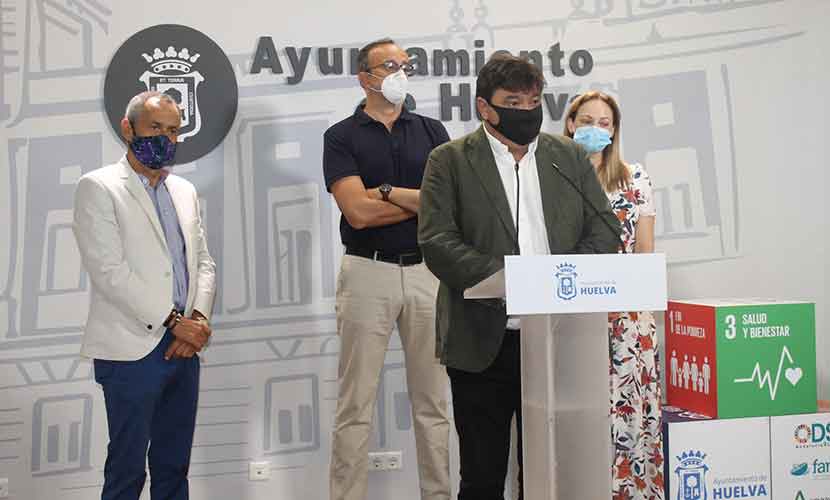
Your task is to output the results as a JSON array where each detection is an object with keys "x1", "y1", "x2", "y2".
[{"x1": 323, "y1": 39, "x2": 450, "y2": 500}]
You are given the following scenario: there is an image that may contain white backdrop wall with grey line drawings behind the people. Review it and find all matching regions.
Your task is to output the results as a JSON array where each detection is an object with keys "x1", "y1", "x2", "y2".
[{"x1": 0, "y1": 0, "x2": 830, "y2": 500}]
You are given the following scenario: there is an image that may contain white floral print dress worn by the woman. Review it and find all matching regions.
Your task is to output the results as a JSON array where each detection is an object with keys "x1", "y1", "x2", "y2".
[{"x1": 607, "y1": 164, "x2": 663, "y2": 500}]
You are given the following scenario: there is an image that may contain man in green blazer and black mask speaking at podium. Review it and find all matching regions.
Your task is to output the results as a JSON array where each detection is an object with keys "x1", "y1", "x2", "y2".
[{"x1": 418, "y1": 55, "x2": 620, "y2": 500}]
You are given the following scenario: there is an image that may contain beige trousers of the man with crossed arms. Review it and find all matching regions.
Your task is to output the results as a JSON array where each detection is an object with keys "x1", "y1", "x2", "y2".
[{"x1": 329, "y1": 255, "x2": 450, "y2": 500}]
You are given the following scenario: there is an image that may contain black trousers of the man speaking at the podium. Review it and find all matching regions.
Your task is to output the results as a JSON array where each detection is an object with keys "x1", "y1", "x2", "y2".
[{"x1": 447, "y1": 332, "x2": 522, "y2": 500}]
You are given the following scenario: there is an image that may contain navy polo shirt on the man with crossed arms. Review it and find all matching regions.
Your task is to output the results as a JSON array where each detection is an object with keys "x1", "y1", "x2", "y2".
[{"x1": 323, "y1": 106, "x2": 450, "y2": 253}]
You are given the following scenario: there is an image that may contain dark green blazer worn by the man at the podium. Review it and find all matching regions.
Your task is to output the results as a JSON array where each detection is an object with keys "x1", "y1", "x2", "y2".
[{"x1": 418, "y1": 127, "x2": 620, "y2": 372}]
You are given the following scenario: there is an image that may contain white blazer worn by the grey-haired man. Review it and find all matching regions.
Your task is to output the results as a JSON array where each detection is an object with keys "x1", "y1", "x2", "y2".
[{"x1": 73, "y1": 156, "x2": 216, "y2": 361}]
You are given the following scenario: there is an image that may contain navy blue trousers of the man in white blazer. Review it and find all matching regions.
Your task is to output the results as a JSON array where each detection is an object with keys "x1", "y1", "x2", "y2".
[{"x1": 94, "y1": 331, "x2": 199, "y2": 500}]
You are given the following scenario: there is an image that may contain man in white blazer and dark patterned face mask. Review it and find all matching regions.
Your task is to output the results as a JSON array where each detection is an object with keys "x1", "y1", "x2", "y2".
[{"x1": 73, "y1": 92, "x2": 216, "y2": 500}]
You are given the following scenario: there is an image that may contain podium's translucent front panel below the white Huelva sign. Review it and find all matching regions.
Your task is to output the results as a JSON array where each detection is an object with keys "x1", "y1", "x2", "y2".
[{"x1": 521, "y1": 313, "x2": 612, "y2": 500}]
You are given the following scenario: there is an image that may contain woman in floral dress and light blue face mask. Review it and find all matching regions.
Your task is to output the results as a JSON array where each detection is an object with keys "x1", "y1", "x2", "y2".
[{"x1": 565, "y1": 91, "x2": 663, "y2": 500}]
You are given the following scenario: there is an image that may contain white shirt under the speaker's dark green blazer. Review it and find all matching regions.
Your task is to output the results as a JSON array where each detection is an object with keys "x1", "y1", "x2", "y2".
[{"x1": 484, "y1": 127, "x2": 550, "y2": 330}]
